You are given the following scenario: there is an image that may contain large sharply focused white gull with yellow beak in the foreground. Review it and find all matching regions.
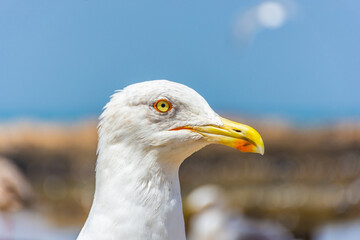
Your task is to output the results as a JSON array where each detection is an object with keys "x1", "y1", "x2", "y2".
[{"x1": 77, "y1": 80, "x2": 264, "y2": 240}]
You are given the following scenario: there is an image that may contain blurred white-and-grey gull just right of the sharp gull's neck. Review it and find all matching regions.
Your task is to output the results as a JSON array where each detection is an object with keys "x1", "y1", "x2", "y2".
[{"x1": 185, "y1": 185, "x2": 293, "y2": 240}]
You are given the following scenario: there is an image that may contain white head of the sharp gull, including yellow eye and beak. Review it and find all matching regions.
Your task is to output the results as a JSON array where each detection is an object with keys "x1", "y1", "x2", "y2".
[{"x1": 99, "y1": 80, "x2": 264, "y2": 165}]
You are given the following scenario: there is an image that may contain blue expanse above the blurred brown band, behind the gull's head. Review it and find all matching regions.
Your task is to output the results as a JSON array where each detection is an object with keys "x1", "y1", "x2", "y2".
[{"x1": 0, "y1": 0, "x2": 360, "y2": 121}]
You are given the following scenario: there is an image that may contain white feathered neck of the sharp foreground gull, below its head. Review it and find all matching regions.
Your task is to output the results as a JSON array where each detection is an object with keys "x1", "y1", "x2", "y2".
[{"x1": 78, "y1": 145, "x2": 185, "y2": 240}]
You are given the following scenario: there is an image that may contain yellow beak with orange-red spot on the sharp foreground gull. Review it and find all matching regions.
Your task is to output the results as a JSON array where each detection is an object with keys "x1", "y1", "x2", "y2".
[{"x1": 173, "y1": 117, "x2": 264, "y2": 155}]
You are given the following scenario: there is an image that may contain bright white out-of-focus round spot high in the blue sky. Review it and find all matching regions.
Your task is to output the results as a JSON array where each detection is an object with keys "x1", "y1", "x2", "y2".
[{"x1": 257, "y1": 2, "x2": 286, "y2": 28}]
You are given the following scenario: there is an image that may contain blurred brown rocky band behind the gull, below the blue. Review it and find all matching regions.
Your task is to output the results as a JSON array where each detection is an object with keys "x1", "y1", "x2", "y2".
[{"x1": 0, "y1": 118, "x2": 360, "y2": 238}]
